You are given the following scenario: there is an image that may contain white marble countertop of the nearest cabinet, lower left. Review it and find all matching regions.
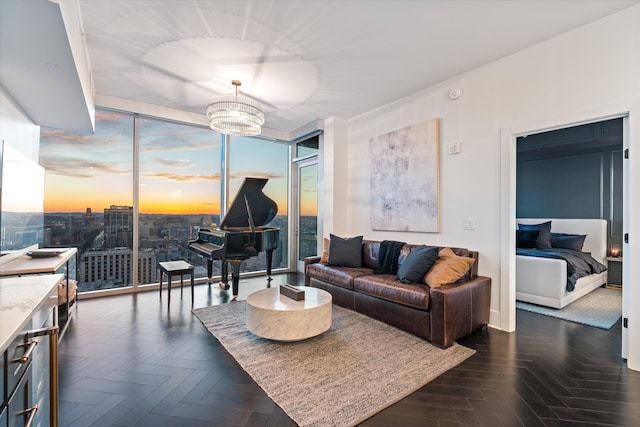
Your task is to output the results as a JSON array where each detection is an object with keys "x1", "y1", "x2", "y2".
[{"x1": 0, "y1": 274, "x2": 64, "y2": 352}]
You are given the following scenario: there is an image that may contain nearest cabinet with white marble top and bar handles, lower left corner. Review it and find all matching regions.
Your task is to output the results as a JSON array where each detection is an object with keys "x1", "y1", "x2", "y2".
[{"x1": 0, "y1": 274, "x2": 64, "y2": 427}]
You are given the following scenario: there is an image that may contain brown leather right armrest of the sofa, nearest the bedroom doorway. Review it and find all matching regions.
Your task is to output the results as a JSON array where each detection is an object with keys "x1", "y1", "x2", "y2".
[{"x1": 429, "y1": 276, "x2": 491, "y2": 347}]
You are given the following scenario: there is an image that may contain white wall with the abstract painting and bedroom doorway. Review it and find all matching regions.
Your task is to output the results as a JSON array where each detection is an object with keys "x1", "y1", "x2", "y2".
[{"x1": 324, "y1": 6, "x2": 640, "y2": 369}]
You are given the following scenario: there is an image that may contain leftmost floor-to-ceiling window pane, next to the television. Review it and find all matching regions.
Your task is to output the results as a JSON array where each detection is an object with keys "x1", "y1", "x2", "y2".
[{"x1": 40, "y1": 110, "x2": 133, "y2": 292}]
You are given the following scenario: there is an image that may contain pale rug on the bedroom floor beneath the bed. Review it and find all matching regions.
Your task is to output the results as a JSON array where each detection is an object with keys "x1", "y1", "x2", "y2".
[{"x1": 516, "y1": 288, "x2": 622, "y2": 329}]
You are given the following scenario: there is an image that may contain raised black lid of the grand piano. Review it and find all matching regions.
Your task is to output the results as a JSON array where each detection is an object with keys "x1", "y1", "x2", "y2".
[{"x1": 220, "y1": 178, "x2": 278, "y2": 230}]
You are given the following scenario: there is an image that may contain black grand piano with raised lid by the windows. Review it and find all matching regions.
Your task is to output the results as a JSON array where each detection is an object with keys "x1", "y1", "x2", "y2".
[{"x1": 187, "y1": 178, "x2": 280, "y2": 297}]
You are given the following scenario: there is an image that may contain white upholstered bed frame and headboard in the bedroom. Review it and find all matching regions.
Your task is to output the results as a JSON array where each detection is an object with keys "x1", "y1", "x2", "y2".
[{"x1": 516, "y1": 218, "x2": 607, "y2": 308}]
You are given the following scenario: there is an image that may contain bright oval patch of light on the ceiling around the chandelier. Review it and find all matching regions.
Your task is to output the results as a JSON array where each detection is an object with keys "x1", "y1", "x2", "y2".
[{"x1": 141, "y1": 37, "x2": 318, "y2": 113}]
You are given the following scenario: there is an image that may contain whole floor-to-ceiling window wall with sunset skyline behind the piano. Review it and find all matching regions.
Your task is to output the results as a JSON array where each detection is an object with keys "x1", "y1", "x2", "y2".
[{"x1": 40, "y1": 109, "x2": 289, "y2": 292}]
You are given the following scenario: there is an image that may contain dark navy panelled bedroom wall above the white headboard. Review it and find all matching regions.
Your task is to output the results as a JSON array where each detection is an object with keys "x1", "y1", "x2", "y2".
[{"x1": 516, "y1": 118, "x2": 623, "y2": 249}]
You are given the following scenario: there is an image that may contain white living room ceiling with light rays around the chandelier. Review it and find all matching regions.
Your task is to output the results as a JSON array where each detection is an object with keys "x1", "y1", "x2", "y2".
[{"x1": 0, "y1": 0, "x2": 639, "y2": 135}]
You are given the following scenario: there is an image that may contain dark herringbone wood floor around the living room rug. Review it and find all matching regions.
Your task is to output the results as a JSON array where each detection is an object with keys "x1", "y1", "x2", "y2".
[{"x1": 59, "y1": 275, "x2": 640, "y2": 427}]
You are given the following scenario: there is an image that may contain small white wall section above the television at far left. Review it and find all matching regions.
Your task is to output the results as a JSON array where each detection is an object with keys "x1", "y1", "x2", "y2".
[{"x1": 0, "y1": 87, "x2": 40, "y2": 162}]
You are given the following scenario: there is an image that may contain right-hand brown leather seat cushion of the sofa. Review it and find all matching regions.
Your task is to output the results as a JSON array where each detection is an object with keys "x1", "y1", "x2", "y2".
[{"x1": 353, "y1": 274, "x2": 429, "y2": 310}]
